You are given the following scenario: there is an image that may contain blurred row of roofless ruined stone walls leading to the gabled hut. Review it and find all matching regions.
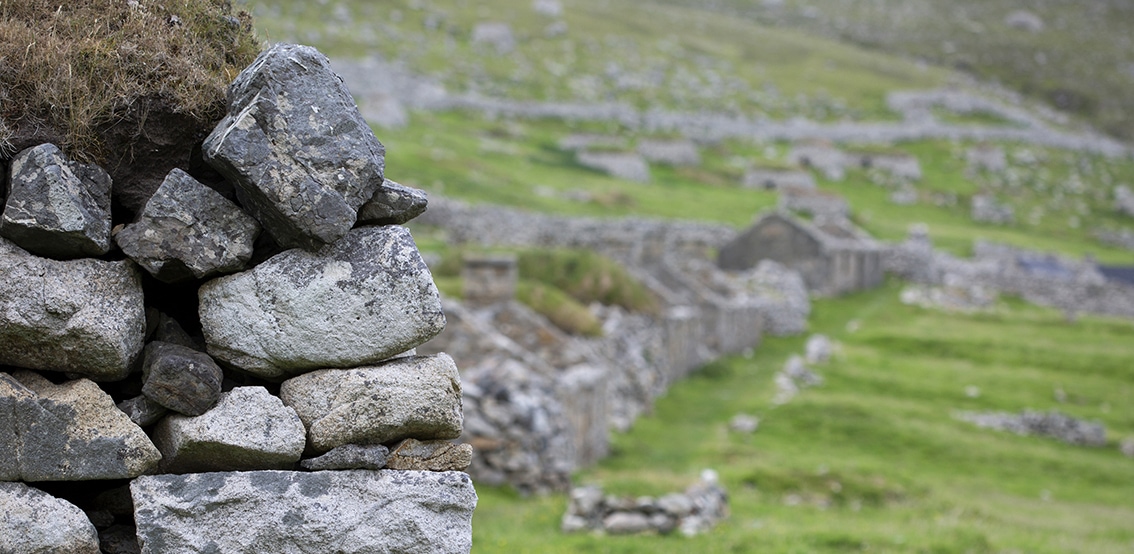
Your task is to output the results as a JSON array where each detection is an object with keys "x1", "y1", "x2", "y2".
[{"x1": 414, "y1": 196, "x2": 810, "y2": 492}]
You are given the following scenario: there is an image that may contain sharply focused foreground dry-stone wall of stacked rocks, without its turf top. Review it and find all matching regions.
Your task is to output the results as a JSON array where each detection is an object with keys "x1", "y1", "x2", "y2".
[{"x1": 0, "y1": 44, "x2": 476, "y2": 554}]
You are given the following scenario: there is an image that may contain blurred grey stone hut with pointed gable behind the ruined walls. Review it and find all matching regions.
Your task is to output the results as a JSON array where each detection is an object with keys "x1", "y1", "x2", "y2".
[{"x1": 717, "y1": 212, "x2": 883, "y2": 296}]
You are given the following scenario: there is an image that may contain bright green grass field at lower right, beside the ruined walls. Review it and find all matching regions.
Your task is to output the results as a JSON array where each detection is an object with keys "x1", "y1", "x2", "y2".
[{"x1": 473, "y1": 283, "x2": 1134, "y2": 553}]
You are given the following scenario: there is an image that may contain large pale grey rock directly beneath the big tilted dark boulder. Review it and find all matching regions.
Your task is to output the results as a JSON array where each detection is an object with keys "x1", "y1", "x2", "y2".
[{"x1": 200, "y1": 225, "x2": 445, "y2": 380}]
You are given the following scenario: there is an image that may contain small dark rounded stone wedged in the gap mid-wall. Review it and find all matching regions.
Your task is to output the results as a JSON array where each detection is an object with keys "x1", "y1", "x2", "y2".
[{"x1": 142, "y1": 341, "x2": 225, "y2": 416}]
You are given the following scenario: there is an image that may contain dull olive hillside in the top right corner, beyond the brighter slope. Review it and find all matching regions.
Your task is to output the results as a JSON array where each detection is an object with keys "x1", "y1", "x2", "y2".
[{"x1": 662, "y1": 0, "x2": 1134, "y2": 140}]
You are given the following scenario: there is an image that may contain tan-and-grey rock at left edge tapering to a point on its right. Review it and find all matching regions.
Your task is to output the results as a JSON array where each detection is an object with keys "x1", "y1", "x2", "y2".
[{"x1": 0, "y1": 372, "x2": 161, "y2": 481}]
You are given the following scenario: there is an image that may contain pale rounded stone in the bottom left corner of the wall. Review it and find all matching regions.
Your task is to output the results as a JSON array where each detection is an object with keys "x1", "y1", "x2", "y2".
[{"x1": 0, "y1": 483, "x2": 100, "y2": 554}]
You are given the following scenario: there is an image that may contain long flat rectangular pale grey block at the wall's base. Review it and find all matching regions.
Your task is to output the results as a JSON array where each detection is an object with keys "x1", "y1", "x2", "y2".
[{"x1": 130, "y1": 469, "x2": 476, "y2": 554}]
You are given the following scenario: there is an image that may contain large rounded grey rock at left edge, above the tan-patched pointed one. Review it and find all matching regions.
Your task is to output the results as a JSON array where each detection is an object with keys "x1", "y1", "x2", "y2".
[{"x1": 0, "y1": 239, "x2": 145, "y2": 381}]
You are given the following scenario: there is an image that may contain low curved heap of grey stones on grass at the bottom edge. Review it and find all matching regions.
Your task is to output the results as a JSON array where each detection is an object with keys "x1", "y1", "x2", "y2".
[{"x1": 560, "y1": 470, "x2": 728, "y2": 537}]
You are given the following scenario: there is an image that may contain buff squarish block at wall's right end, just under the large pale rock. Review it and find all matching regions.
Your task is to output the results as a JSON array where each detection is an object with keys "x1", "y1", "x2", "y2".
[{"x1": 280, "y1": 353, "x2": 463, "y2": 452}]
